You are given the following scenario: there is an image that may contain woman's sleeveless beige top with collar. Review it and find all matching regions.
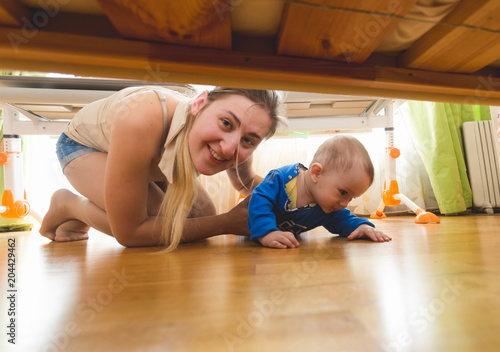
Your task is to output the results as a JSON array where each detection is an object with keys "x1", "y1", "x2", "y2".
[{"x1": 64, "y1": 86, "x2": 189, "y2": 183}]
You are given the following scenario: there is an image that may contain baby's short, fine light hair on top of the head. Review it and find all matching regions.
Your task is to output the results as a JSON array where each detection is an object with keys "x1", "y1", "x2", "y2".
[{"x1": 311, "y1": 135, "x2": 375, "y2": 185}]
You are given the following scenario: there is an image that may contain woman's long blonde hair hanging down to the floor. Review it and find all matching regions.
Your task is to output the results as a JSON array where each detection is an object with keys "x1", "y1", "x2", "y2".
[{"x1": 159, "y1": 87, "x2": 286, "y2": 252}]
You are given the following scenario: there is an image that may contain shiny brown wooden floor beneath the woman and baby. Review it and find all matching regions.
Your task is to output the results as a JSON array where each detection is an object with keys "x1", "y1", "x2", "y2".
[{"x1": 0, "y1": 215, "x2": 500, "y2": 352}]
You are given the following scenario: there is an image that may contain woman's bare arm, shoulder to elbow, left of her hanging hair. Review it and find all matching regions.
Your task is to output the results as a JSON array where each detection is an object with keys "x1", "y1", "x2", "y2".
[{"x1": 104, "y1": 92, "x2": 167, "y2": 246}]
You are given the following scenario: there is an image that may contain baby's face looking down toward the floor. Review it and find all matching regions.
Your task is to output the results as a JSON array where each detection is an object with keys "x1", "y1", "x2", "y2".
[{"x1": 313, "y1": 163, "x2": 370, "y2": 213}]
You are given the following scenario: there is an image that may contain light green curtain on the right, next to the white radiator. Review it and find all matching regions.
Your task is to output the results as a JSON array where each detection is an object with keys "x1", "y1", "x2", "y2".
[{"x1": 408, "y1": 101, "x2": 491, "y2": 214}]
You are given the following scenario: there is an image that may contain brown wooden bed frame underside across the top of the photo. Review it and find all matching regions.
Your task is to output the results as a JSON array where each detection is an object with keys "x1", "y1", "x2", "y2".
[{"x1": 0, "y1": 0, "x2": 500, "y2": 105}]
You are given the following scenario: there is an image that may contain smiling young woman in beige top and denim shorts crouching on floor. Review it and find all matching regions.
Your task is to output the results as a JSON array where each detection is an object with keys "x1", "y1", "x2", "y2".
[{"x1": 40, "y1": 86, "x2": 284, "y2": 250}]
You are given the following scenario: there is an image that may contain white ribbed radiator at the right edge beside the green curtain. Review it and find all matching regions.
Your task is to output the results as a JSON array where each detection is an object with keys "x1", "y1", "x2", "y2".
[{"x1": 463, "y1": 120, "x2": 500, "y2": 214}]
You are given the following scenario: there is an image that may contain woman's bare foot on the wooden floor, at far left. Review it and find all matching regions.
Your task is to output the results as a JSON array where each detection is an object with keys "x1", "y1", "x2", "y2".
[{"x1": 40, "y1": 189, "x2": 90, "y2": 242}]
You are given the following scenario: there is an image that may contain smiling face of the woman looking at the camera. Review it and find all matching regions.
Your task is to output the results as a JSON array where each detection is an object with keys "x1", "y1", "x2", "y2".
[{"x1": 189, "y1": 92, "x2": 271, "y2": 175}]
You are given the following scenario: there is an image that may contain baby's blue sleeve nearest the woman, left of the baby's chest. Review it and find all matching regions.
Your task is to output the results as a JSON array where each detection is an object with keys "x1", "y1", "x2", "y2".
[{"x1": 248, "y1": 170, "x2": 282, "y2": 240}]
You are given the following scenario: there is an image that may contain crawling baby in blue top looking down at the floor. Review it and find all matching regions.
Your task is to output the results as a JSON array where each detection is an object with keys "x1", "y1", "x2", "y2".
[{"x1": 248, "y1": 135, "x2": 391, "y2": 248}]
